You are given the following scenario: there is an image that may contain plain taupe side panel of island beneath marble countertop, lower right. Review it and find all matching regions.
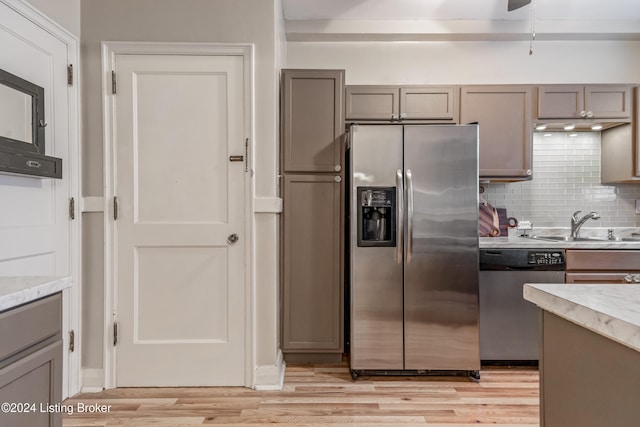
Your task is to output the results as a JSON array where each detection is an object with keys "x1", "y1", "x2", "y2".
[{"x1": 540, "y1": 311, "x2": 640, "y2": 427}]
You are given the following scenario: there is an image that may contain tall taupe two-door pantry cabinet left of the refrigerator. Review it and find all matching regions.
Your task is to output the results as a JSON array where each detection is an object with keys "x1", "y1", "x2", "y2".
[{"x1": 280, "y1": 69, "x2": 345, "y2": 362}]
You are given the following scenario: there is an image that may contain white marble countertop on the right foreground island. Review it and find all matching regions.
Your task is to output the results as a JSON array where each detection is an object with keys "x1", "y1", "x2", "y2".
[{"x1": 524, "y1": 283, "x2": 640, "y2": 351}]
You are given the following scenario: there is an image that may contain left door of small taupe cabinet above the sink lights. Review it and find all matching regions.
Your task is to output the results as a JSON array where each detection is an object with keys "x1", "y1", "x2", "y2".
[{"x1": 538, "y1": 85, "x2": 584, "y2": 119}]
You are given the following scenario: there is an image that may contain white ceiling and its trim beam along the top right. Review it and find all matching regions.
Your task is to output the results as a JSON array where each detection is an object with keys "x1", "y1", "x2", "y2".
[{"x1": 282, "y1": 0, "x2": 640, "y2": 41}]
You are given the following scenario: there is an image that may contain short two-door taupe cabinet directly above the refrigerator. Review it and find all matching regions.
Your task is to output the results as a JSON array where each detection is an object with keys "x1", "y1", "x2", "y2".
[{"x1": 345, "y1": 86, "x2": 459, "y2": 123}]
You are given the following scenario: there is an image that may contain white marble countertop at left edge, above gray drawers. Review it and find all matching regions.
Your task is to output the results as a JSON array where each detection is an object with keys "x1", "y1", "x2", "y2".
[{"x1": 0, "y1": 276, "x2": 72, "y2": 311}]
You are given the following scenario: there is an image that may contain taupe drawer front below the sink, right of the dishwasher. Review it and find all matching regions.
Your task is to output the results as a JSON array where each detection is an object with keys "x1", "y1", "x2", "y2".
[{"x1": 566, "y1": 250, "x2": 640, "y2": 271}]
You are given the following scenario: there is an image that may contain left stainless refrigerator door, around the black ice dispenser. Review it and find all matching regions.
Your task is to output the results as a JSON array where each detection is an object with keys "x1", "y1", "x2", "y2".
[{"x1": 350, "y1": 125, "x2": 403, "y2": 370}]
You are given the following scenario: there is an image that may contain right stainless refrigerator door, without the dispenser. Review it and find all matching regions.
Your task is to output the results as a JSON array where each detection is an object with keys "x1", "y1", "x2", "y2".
[{"x1": 404, "y1": 125, "x2": 480, "y2": 370}]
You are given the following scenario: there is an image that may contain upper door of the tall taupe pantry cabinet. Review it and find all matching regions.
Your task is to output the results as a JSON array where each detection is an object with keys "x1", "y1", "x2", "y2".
[{"x1": 282, "y1": 70, "x2": 344, "y2": 172}]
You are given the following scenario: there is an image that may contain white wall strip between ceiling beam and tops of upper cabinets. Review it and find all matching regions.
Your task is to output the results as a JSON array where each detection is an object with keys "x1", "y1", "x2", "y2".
[{"x1": 287, "y1": 41, "x2": 640, "y2": 84}]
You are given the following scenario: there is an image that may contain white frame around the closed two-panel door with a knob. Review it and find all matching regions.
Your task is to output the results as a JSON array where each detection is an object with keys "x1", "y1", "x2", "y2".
[{"x1": 102, "y1": 42, "x2": 255, "y2": 389}]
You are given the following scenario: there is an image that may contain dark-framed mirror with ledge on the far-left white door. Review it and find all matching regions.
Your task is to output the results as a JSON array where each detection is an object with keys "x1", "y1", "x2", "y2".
[{"x1": 0, "y1": 69, "x2": 62, "y2": 178}]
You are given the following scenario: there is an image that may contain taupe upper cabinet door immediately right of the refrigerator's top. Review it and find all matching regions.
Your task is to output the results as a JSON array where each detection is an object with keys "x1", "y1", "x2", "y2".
[{"x1": 460, "y1": 86, "x2": 533, "y2": 181}]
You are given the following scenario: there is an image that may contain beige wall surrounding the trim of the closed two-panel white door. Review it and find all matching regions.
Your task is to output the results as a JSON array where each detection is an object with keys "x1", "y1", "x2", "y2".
[{"x1": 81, "y1": 0, "x2": 278, "y2": 390}]
